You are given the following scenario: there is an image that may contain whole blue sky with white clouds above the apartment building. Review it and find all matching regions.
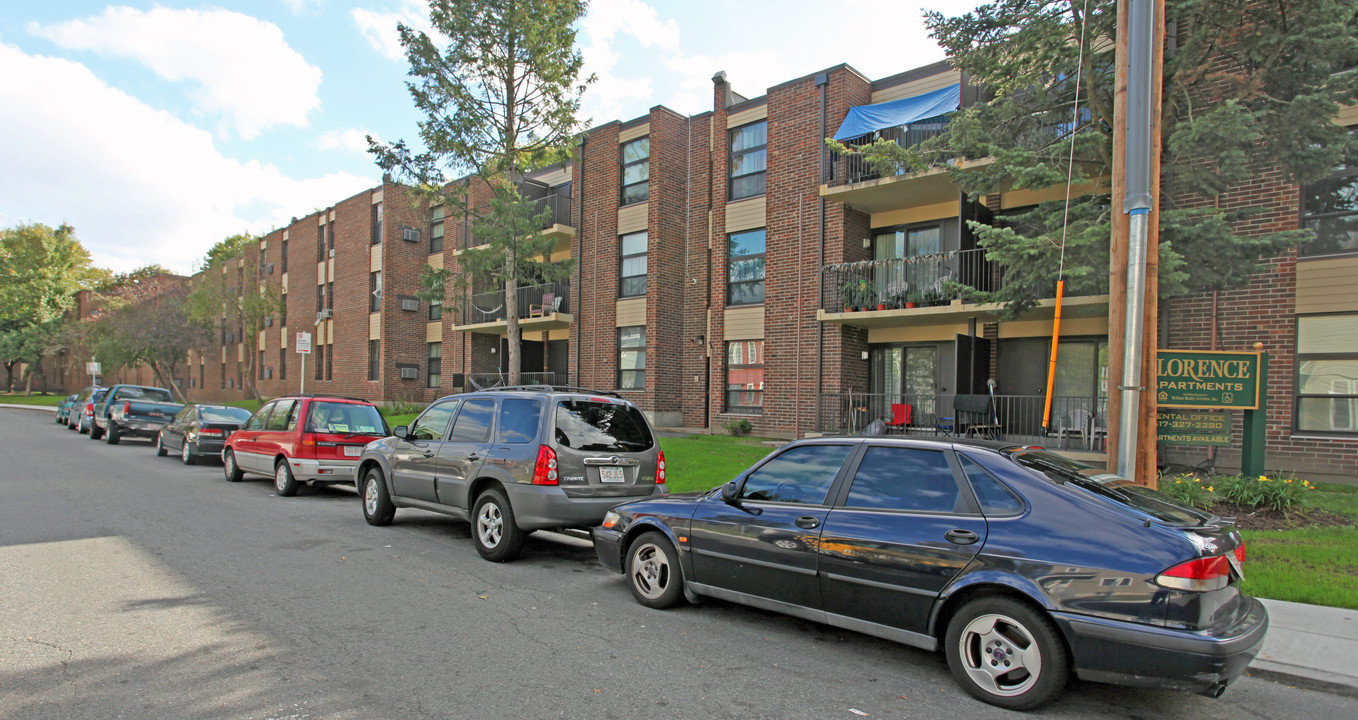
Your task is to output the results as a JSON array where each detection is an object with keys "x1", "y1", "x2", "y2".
[{"x1": 0, "y1": 0, "x2": 956, "y2": 273}]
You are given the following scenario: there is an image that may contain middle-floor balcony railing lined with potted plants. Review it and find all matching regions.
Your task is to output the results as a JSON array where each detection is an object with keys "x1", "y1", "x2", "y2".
[{"x1": 820, "y1": 249, "x2": 1108, "y2": 312}]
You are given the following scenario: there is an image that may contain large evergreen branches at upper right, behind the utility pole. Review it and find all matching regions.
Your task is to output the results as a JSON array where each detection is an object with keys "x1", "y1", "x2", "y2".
[{"x1": 831, "y1": 0, "x2": 1358, "y2": 312}]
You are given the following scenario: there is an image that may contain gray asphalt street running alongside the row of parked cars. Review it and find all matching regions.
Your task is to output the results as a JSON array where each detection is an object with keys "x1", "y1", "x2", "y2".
[{"x1": 0, "y1": 409, "x2": 1358, "y2": 720}]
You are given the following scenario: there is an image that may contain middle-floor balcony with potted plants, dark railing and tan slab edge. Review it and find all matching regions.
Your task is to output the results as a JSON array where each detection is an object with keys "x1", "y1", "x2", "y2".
[{"x1": 816, "y1": 250, "x2": 1108, "y2": 329}]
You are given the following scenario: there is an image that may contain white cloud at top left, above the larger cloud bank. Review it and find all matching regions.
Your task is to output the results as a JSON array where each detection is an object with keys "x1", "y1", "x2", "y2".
[{"x1": 29, "y1": 7, "x2": 320, "y2": 140}]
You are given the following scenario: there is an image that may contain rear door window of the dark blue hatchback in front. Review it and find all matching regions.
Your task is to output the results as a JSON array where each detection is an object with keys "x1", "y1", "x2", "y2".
[{"x1": 845, "y1": 447, "x2": 960, "y2": 512}]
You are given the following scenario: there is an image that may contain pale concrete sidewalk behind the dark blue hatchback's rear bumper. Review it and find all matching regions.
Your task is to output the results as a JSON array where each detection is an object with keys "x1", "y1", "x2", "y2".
[{"x1": 1249, "y1": 599, "x2": 1358, "y2": 697}]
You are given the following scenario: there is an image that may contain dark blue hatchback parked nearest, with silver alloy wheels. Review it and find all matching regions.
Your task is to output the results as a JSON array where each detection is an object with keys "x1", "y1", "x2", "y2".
[{"x1": 593, "y1": 437, "x2": 1268, "y2": 709}]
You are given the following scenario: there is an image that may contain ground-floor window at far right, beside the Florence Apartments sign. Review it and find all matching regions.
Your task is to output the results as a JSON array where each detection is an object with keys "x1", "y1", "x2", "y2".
[{"x1": 1293, "y1": 314, "x2": 1358, "y2": 435}]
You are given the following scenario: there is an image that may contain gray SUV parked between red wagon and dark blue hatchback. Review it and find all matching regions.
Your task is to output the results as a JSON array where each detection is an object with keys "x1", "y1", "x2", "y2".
[{"x1": 357, "y1": 386, "x2": 668, "y2": 562}]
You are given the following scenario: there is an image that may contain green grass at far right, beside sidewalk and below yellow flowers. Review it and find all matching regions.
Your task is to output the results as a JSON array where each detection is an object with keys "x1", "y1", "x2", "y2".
[{"x1": 1241, "y1": 484, "x2": 1358, "y2": 610}]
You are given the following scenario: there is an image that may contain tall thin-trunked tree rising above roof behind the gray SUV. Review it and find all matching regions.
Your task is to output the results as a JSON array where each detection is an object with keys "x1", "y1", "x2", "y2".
[{"x1": 368, "y1": 0, "x2": 592, "y2": 383}]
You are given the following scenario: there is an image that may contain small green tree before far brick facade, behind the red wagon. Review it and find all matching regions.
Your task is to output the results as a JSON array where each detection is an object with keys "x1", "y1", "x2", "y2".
[{"x1": 186, "y1": 232, "x2": 282, "y2": 399}]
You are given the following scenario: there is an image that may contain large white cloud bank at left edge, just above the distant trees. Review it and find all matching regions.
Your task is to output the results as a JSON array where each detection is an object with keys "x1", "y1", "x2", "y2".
[{"x1": 0, "y1": 43, "x2": 375, "y2": 272}]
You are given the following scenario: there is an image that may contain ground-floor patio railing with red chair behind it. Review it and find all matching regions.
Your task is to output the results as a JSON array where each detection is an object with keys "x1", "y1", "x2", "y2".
[{"x1": 818, "y1": 393, "x2": 1108, "y2": 450}]
